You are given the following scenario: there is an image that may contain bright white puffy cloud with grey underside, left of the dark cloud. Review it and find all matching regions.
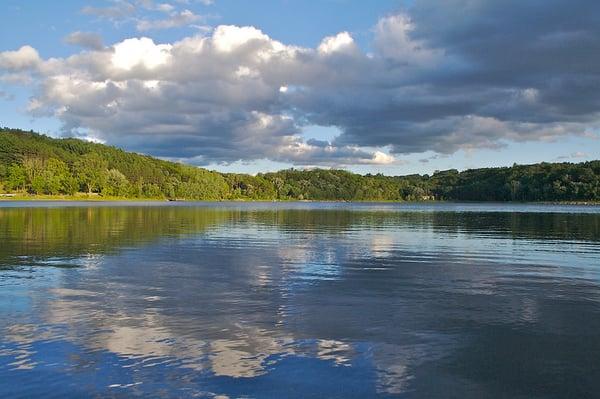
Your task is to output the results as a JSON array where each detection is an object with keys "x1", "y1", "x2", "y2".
[{"x1": 12, "y1": 26, "x2": 384, "y2": 165}]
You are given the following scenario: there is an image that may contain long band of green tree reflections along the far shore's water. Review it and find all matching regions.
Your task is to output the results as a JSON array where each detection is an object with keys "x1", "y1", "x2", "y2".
[{"x1": 0, "y1": 206, "x2": 600, "y2": 259}]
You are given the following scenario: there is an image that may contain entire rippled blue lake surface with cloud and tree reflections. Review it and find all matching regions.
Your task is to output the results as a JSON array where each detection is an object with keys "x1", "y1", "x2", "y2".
[{"x1": 0, "y1": 202, "x2": 600, "y2": 398}]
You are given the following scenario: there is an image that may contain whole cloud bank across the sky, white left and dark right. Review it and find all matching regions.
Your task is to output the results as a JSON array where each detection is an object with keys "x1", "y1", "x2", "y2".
[{"x1": 0, "y1": 0, "x2": 600, "y2": 165}]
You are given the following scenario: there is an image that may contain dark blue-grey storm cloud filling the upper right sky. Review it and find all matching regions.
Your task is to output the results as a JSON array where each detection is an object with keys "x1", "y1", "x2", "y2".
[{"x1": 290, "y1": 0, "x2": 600, "y2": 153}]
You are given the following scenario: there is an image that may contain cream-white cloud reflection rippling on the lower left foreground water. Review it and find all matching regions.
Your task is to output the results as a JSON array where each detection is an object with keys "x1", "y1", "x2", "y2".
[{"x1": 34, "y1": 278, "x2": 304, "y2": 378}]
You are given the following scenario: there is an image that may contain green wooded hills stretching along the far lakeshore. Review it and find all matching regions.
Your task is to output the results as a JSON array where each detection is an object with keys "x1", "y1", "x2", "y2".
[{"x1": 0, "y1": 128, "x2": 600, "y2": 202}]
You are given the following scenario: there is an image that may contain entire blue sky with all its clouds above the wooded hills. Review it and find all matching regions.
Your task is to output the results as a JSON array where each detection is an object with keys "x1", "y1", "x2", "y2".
[{"x1": 0, "y1": 0, "x2": 600, "y2": 175}]
